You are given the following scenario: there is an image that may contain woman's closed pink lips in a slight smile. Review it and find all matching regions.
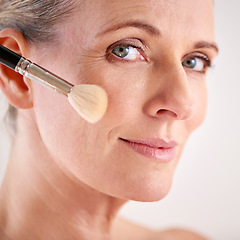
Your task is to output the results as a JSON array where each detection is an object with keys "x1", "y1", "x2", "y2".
[{"x1": 120, "y1": 138, "x2": 177, "y2": 163}]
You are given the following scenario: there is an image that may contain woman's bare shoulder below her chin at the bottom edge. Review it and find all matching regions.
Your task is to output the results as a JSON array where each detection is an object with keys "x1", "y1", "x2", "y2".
[{"x1": 113, "y1": 218, "x2": 207, "y2": 240}]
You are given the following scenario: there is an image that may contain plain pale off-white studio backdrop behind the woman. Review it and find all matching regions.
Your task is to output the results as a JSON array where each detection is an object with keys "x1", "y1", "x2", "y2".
[{"x1": 0, "y1": 0, "x2": 240, "y2": 240}]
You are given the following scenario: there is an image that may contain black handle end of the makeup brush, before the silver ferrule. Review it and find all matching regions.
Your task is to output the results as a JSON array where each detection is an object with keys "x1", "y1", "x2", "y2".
[{"x1": 0, "y1": 45, "x2": 22, "y2": 70}]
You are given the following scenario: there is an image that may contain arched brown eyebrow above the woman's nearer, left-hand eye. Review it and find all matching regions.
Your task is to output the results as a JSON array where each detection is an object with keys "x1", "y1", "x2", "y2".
[{"x1": 98, "y1": 21, "x2": 162, "y2": 36}]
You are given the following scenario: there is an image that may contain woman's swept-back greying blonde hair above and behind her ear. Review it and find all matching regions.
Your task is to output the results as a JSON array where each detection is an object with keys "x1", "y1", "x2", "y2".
[{"x1": 0, "y1": 0, "x2": 78, "y2": 131}]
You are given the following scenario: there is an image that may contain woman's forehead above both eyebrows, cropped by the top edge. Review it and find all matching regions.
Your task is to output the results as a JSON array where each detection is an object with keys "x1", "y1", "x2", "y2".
[{"x1": 81, "y1": 0, "x2": 214, "y2": 37}]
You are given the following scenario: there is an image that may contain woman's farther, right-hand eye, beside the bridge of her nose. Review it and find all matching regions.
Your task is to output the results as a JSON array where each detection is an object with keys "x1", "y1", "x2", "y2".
[{"x1": 182, "y1": 53, "x2": 211, "y2": 72}]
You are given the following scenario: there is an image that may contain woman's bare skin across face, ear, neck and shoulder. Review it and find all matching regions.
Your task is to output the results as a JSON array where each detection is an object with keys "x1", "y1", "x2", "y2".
[{"x1": 0, "y1": 0, "x2": 217, "y2": 240}]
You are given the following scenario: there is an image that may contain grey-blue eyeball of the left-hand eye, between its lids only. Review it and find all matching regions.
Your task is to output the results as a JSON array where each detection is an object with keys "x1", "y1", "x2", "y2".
[{"x1": 112, "y1": 45, "x2": 144, "y2": 60}]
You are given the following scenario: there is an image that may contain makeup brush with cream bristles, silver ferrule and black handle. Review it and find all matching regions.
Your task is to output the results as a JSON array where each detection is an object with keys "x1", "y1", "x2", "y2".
[{"x1": 0, "y1": 45, "x2": 108, "y2": 123}]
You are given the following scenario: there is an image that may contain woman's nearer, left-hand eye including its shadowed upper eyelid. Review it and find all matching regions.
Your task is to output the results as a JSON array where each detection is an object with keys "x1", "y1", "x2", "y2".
[{"x1": 107, "y1": 39, "x2": 146, "y2": 62}]
